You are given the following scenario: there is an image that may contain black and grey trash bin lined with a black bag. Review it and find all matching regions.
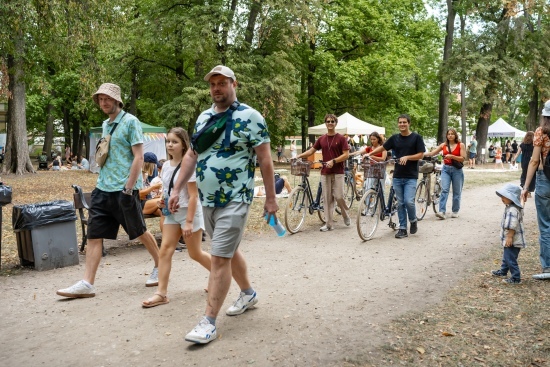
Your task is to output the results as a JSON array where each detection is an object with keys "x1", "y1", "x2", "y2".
[{"x1": 12, "y1": 200, "x2": 78, "y2": 270}]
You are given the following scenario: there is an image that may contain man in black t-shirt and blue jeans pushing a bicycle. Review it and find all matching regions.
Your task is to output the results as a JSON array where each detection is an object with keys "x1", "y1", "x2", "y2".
[{"x1": 367, "y1": 114, "x2": 426, "y2": 238}]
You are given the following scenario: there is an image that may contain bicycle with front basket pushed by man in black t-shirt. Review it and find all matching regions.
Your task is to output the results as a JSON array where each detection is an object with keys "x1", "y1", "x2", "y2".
[{"x1": 357, "y1": 158, "x2": 397, "y2": 241}]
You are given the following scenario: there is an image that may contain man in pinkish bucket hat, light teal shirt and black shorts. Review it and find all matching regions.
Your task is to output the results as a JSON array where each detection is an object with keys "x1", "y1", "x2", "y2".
[{"x1": 57, "y1": 83, "x2": 159, "y2": 298}]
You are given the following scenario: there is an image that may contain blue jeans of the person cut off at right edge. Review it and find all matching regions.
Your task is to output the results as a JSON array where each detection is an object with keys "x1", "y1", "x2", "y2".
[{"x1": 535, "y1": 171, "x2": 550, "y2": 272}]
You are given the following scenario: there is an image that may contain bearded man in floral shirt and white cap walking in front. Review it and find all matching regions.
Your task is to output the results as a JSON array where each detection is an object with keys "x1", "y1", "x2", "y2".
[{"x1": 169, "y1": 65, "x2": 279, "y2": 344}]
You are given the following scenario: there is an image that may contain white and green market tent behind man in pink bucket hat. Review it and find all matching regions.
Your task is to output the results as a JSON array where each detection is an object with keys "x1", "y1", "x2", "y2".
[{"x1": 90, "y1": 122, "x2": 167, "y2": 173}]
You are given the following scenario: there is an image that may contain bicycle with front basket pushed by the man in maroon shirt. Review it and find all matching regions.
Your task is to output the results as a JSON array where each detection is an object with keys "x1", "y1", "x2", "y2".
[{"x1": 285, "y1": 160, "x2": 326, "y2": 234}]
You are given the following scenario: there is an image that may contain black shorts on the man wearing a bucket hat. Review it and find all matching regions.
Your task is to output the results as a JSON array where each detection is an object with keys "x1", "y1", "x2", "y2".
[{"x1": 88, "y1": 188, "x2": 147, "y2": 240}]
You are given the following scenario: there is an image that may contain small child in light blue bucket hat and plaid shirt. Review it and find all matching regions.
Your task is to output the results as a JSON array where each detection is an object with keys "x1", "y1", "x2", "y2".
[{"x1": 492, "y1": 184, "x2": 525, "y2": 284}]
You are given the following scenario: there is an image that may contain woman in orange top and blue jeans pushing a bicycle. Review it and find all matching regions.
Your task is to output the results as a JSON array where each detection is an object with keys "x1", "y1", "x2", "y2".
[{"x1": 424, "y1": 128, "x2": 466, "y2": 219}]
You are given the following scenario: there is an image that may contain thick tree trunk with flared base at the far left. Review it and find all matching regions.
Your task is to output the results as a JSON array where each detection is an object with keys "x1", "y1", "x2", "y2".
[{"x1": 2, "y1": 32, "x2": 35, "y2": 175}]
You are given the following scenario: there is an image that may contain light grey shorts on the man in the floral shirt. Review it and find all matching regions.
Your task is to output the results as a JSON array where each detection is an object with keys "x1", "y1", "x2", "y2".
[{"x1": 202, "y1": 201, "x2": 250, "y2": 259}]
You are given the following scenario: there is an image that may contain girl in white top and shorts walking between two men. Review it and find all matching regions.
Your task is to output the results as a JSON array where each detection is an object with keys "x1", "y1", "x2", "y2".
[{"x1": 142, "y1": 127, "x2": 211, "y2": 308}]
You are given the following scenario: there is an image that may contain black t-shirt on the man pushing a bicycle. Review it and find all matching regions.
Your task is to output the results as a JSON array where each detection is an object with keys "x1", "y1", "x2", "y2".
[{"x1": 384, "y1": 133, "x2": 426, "y2": 179}]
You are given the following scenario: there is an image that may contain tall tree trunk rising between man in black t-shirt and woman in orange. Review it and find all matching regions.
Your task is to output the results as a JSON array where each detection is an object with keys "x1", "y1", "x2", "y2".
[{"x1": 437, "y1": 0, "x2": 457, "y2": 143}]
